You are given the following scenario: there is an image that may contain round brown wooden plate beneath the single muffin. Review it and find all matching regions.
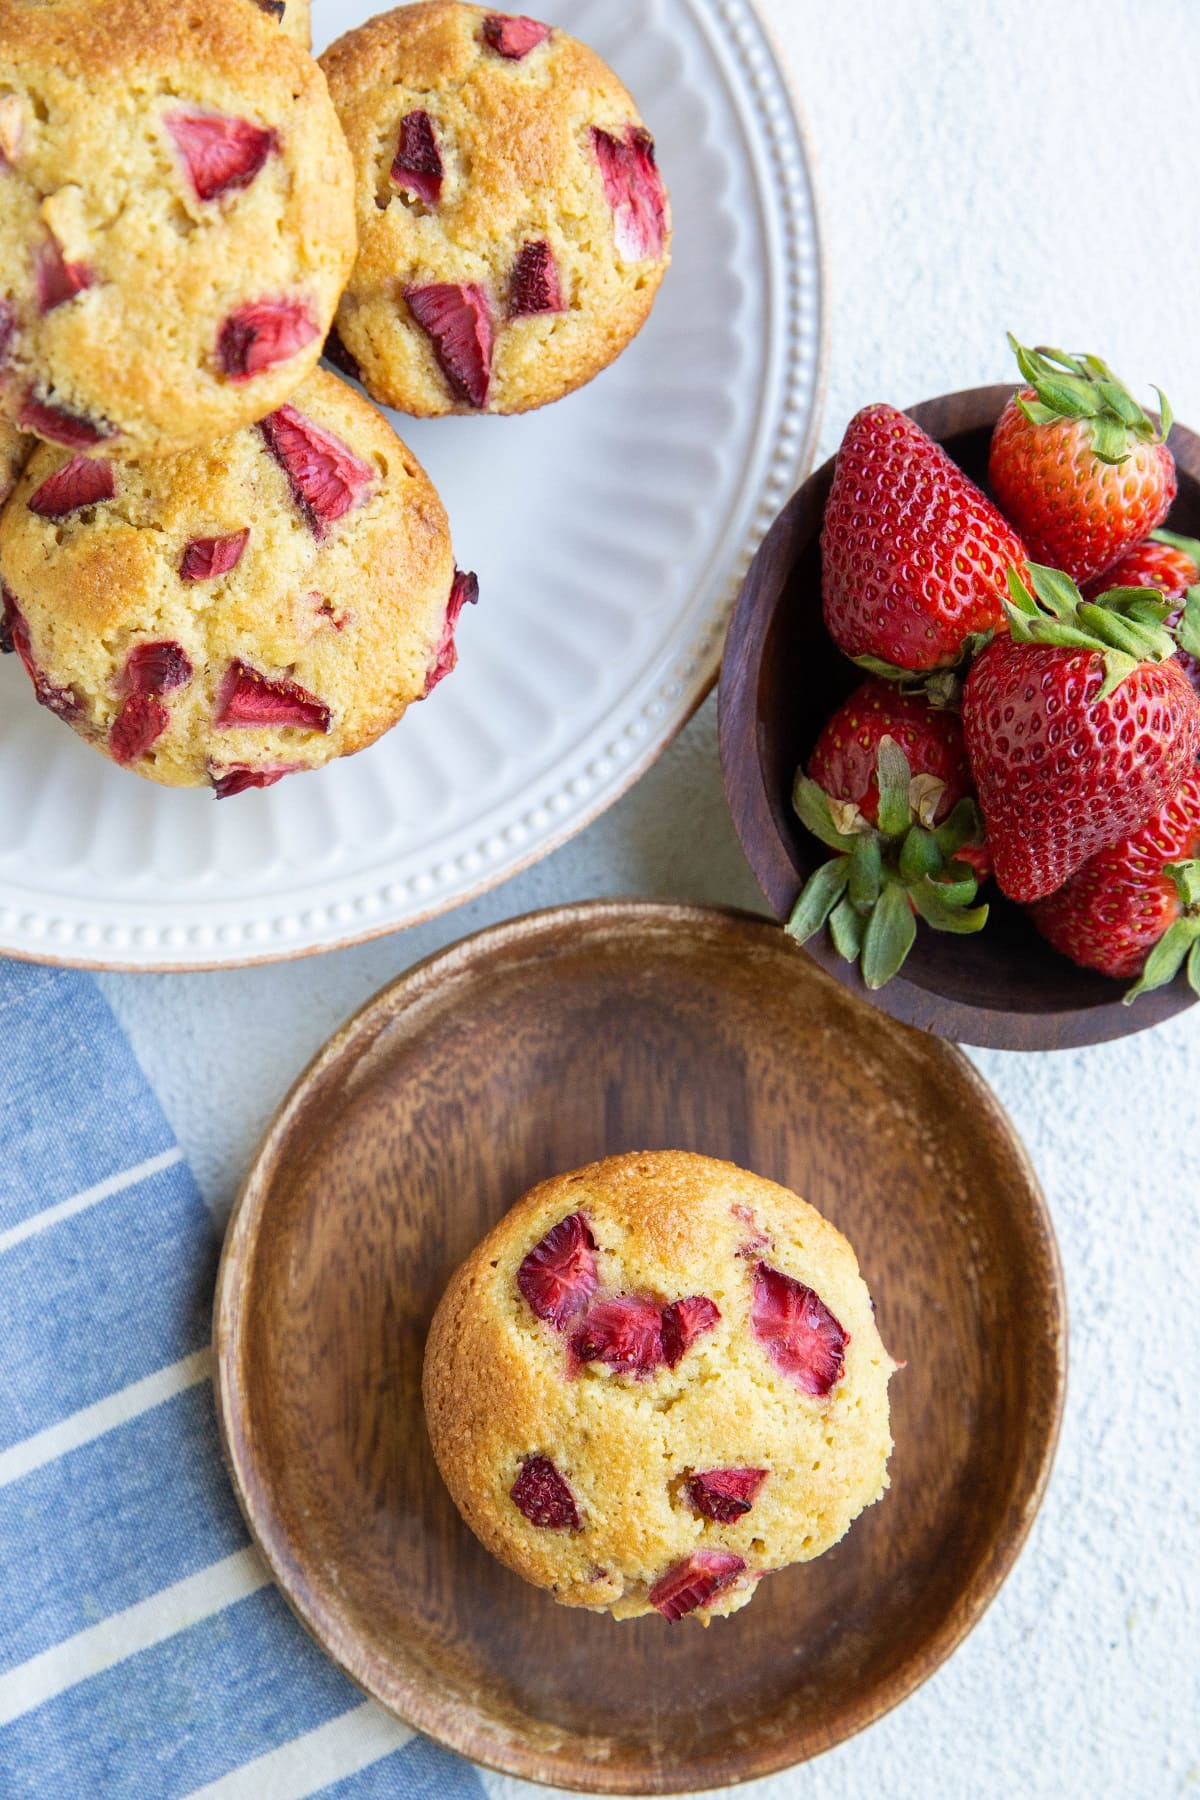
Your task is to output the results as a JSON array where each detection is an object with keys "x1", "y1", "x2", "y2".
[{"x1": 216, "y1": 902, "x2": 1065, "y2": 1793}]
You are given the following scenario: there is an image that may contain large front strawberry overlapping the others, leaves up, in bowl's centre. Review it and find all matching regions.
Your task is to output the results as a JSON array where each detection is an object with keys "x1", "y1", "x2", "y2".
[{"x1": 963, "y1": 565, "x2": 1200, "y2": 902}]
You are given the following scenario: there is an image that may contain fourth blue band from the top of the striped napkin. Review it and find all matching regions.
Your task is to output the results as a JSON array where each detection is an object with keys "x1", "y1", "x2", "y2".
[{"x1": 0, "y1": 1588, "x2": 362, "y2": 1800}]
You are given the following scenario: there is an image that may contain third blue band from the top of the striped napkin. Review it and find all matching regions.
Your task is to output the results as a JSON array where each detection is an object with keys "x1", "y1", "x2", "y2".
[{"x1": 0, "y1": 1382, "x2": 246, "y2": 1677}]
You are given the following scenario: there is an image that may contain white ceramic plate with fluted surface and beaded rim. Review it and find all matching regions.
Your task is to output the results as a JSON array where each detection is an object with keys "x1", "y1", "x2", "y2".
[{"x1": 0, "y1": 0, "x2": 822, "y2": 968}]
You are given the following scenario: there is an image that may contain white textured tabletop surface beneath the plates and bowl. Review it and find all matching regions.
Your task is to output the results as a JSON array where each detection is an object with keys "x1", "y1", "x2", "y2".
[{"x1": 103, "y1": 0, "x2": 1200, "y2": 1800}]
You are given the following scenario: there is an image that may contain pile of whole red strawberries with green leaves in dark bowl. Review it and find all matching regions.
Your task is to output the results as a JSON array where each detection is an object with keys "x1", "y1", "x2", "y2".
[{"x1": 788, "y1": 338, "x2": 1200, "y2": 999}]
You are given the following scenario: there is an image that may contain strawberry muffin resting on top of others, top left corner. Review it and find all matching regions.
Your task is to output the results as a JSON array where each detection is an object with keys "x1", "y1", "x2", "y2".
[{"x1": 0, "y1": 0, "x2": 354, "y2": 459}]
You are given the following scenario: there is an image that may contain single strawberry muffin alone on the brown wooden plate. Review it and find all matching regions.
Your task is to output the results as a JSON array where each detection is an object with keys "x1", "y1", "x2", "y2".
[{"x1": 425, "y1": 1150, "x2": 896, "y2": 1624}]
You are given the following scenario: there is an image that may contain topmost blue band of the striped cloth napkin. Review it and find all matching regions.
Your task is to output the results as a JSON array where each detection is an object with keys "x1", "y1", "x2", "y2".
[{"x1": 0, "y1": 961, "x2": 175, "y2": 1231}]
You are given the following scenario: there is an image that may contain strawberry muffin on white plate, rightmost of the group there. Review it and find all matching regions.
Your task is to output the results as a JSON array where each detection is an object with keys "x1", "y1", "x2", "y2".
[{"x1": 320, "y1": 0, "x2": 671, "y2": 418}]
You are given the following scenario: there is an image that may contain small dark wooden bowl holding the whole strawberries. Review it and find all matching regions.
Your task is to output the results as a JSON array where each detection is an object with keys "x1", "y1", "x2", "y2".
[{"x1": 720, "y1": 383, "x2": 1200, "y2": 1049}]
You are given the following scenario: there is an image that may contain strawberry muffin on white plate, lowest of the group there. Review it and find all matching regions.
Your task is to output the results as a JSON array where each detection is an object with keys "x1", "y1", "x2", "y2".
[{"x1": 0, "y1": 369, "x2": 477, "y2": 797}]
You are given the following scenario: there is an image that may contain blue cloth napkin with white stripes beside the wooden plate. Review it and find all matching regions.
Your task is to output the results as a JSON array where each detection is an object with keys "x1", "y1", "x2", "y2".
[{"x1": 0, "y1": 961, "x2": 484, "y2": 1800}]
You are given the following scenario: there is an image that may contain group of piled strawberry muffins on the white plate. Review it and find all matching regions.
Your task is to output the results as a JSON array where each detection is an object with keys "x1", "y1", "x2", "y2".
[{"x1": 0, "y1": 0, "x2": 669, "y2": 797}]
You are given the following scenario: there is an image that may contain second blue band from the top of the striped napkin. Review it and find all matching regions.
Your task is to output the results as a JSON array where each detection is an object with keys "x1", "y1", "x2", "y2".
[{"x1": 0, "y1": 1163, "x2": 218, "y2": 1449}]
